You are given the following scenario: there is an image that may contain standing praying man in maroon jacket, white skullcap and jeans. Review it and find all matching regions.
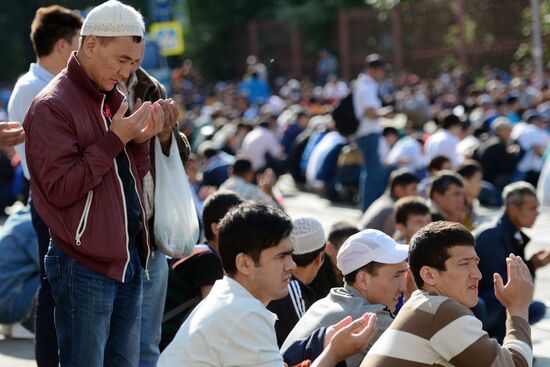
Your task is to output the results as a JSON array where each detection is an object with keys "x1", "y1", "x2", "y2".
[{"x1": 24, "y1": 0, "x2": 164, "y2": 366}]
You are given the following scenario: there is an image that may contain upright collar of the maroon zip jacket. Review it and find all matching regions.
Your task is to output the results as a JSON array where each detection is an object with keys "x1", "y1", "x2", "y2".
[{"x1": 63, "y1": 51, "x2": 124, "y2": 111}]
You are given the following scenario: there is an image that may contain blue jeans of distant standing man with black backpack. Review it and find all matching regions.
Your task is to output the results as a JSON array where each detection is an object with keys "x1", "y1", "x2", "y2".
[{"x1": 357, "y1": 133, "x2": 387, "y2": 211}]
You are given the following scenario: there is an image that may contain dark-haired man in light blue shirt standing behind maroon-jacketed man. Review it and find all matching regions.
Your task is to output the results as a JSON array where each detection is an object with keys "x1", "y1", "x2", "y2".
[{"x1": 8, "y1": 5, "x2": 82, "y2": 367}]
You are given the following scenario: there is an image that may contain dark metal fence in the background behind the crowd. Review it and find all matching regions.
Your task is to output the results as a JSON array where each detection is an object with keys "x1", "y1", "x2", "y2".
[{"x1": 239, "y1": 0, "x2": 529, "y2": 79}]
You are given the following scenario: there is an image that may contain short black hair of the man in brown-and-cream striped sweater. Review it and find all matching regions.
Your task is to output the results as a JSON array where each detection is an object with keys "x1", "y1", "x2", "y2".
[{"x1": 409, "y1": 221, "x2": 476, "y2": 289}]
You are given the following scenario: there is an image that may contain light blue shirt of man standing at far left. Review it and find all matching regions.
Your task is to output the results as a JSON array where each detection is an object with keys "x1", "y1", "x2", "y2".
[{"x1": 8, "y1": 63, "x2": 55, "y2": 180}]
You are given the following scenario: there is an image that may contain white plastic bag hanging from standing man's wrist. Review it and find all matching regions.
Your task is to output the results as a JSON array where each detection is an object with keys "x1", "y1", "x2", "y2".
[{"x1": 154, "y1": 134, "x2": 200, "y2": 258}]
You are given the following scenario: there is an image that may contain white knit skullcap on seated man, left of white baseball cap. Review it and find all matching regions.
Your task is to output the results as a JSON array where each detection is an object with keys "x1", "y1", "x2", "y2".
[{"x1": 290, "y1": 217, "x2": 326, "y2": 255}]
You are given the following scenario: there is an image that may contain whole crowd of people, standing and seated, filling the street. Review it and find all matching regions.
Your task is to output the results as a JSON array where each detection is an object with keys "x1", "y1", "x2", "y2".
[{"x1": 0, "y1": 0, "x2": 550, "y2": 367}]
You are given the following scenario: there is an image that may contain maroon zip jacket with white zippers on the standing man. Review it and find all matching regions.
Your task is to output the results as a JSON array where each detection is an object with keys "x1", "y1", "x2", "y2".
[{"x1": 23, "y1": 53, "x2": 150, "y2": 281}]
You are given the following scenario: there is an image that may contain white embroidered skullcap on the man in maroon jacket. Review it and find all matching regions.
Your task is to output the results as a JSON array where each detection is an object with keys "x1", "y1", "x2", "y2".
[{"x1": 80, "y1": 0, "x2": 145, "y2": 37}]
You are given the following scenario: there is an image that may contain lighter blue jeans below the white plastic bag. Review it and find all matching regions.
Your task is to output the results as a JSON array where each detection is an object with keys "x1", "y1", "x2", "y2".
[{"x1": 139, "y1": 251, "x2": 168, "y2": 367}]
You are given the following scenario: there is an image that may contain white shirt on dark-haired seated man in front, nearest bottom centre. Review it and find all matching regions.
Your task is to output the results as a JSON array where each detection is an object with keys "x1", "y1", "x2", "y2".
[{"x1": 158, "y1": 276, "x2": 283, "y2": 367}]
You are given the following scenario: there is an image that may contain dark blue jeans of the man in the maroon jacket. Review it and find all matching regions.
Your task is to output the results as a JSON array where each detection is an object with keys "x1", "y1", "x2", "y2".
[{"x1": 44, "y1": 241, "x2": 142, "y2": 367}]
